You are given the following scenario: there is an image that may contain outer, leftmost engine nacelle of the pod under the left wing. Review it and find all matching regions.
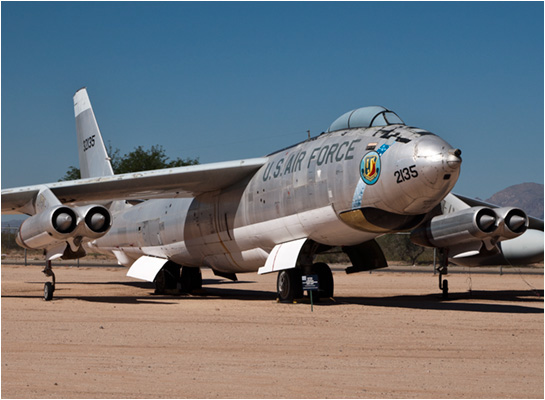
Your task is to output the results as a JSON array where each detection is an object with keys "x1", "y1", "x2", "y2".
[{"x1": 15, "y1": 206, "x2": 78, "y2": 249}]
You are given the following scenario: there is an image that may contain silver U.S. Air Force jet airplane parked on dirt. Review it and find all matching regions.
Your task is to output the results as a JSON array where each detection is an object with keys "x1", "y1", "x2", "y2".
[{"x1": 1, "y1": 88, "x2": 543, "y2": 302}]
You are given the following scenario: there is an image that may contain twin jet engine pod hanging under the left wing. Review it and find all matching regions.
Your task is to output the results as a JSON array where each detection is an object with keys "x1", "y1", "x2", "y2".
[{"x1": 15, "y1": 205, "x2": 112, "y2": 249}]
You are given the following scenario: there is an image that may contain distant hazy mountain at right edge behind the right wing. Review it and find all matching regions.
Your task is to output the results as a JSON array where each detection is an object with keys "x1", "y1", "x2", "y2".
[{"x1": 486, "y1": 183, "x2": 543, "y2": 219}]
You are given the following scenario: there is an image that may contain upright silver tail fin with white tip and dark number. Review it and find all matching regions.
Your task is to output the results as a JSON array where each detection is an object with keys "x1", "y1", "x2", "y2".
[{"x1": 74, "y1": 88, "x2": 114, "y2": 178}]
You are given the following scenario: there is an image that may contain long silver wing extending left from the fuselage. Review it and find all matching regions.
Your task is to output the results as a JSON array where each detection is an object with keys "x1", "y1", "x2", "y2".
[{"x1": 2, "y1": 158, "x2": 268, "y2": 214}]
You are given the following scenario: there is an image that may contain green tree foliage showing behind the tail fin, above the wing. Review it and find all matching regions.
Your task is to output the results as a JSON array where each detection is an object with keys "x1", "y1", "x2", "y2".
[{"x1": 60, "y1": 145, "x2": 199, "y2": 181}]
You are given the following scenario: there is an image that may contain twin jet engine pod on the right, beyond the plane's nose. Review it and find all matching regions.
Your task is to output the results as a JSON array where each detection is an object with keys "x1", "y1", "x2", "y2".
[{"x1": 411, "y1": 207, "x2": 529, "y2": 248}]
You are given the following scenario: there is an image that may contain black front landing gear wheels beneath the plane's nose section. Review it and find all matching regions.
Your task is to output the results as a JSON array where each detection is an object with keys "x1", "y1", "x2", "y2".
[{"x1": 276, "y1": 263, "x2": 334, "y2": 303}]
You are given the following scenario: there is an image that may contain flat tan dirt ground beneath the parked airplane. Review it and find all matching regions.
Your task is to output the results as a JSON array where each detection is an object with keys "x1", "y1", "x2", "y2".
[{"x1": 1, "y1": 265, "x2": 544, "y2": 398}]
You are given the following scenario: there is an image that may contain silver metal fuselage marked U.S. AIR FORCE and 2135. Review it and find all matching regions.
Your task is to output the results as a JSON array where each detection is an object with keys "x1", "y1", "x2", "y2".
[{"x1": 89, "y1": 125, "x2": 461, "y2": 272}]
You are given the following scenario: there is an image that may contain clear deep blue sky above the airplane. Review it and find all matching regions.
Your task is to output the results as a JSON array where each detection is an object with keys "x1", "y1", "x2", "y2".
[{"x1": 1, "y1": 2, "x2": 544, "y2": 199}]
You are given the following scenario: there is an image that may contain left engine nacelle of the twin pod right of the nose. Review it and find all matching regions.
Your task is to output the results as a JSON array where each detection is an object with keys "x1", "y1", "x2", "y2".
[{"x1": 411, "y1": 207, "x2": 501, "y2": 248}]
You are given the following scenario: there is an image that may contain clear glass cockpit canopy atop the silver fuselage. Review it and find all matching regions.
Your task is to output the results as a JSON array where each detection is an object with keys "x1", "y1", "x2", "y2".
[{"x1": 327, "y1": 106, "x2": 405, "y2": 132}]
